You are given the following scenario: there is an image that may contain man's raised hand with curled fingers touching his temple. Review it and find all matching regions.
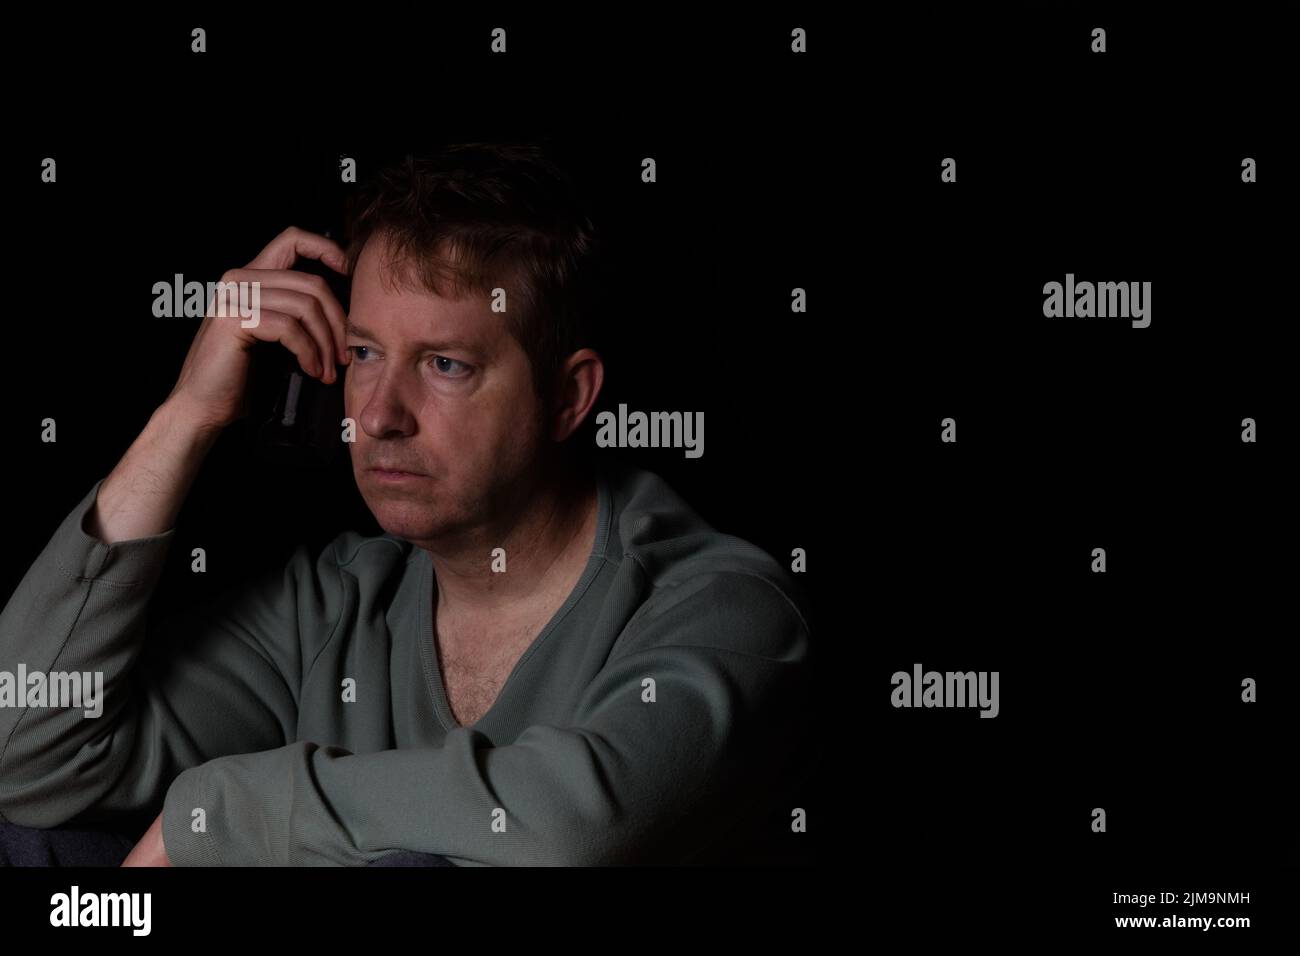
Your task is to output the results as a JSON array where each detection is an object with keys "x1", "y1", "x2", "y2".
[{"x1": 166, "y1": 226, "x2": 348, "y2": 432}]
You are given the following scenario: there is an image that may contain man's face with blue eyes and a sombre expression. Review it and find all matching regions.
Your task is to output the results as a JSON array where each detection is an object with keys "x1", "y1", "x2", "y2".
[{"x1": 343, "y1": 238, "x2": 545, "y2": 544}]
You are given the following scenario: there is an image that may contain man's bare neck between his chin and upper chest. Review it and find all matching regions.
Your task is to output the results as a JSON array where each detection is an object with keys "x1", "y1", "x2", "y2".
[{"x1": 425, "y1": 460, "x2": 598, "y2": 622}]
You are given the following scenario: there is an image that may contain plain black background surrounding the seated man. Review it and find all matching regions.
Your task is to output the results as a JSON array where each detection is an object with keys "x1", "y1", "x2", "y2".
[{"x1": 3, "y1": 4, "x2": 1300, "y2": 947}]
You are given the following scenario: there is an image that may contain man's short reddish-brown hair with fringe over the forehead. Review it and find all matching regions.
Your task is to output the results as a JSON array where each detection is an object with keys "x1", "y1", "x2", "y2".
[{"x1": 347, "y1": 143, "x2": 601, "y2": 408}]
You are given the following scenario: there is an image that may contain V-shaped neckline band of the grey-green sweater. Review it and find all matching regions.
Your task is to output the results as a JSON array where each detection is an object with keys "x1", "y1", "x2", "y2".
[{"x1": 416, "y1": 467, "x2": 612, "y2": 732}]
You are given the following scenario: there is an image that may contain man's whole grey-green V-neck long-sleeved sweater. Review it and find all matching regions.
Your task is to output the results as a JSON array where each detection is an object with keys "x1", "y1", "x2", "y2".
[{"x1": 0, "y1": 460, "x2": 811, "y2": 866}]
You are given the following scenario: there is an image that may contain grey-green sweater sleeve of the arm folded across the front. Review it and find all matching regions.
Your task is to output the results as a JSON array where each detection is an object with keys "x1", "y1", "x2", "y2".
[{"x1": 163, "y1": 572, "x2": 809, "y2": 866}]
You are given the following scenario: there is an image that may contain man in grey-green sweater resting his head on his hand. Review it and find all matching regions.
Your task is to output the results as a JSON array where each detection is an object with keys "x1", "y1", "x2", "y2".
[{"x1": 0, "y1": 144, "x2": 809, "y2": 865}]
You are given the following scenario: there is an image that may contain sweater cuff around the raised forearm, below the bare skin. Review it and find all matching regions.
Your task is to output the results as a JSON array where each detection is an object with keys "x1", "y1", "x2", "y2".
[{"x1": 46, "y1": 479, "x2": 176, "y2": 588}]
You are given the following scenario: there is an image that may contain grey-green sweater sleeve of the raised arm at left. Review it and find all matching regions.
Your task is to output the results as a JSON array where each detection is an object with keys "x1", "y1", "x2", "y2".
[{"x1": 0, "y1": 480, "x2": 309, "y2": 827}]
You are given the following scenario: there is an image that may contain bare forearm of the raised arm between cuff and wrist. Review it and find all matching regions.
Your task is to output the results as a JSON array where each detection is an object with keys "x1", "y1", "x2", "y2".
[{"x1": 86, "y1": 402, "x2": 220, "y2": 544}]
